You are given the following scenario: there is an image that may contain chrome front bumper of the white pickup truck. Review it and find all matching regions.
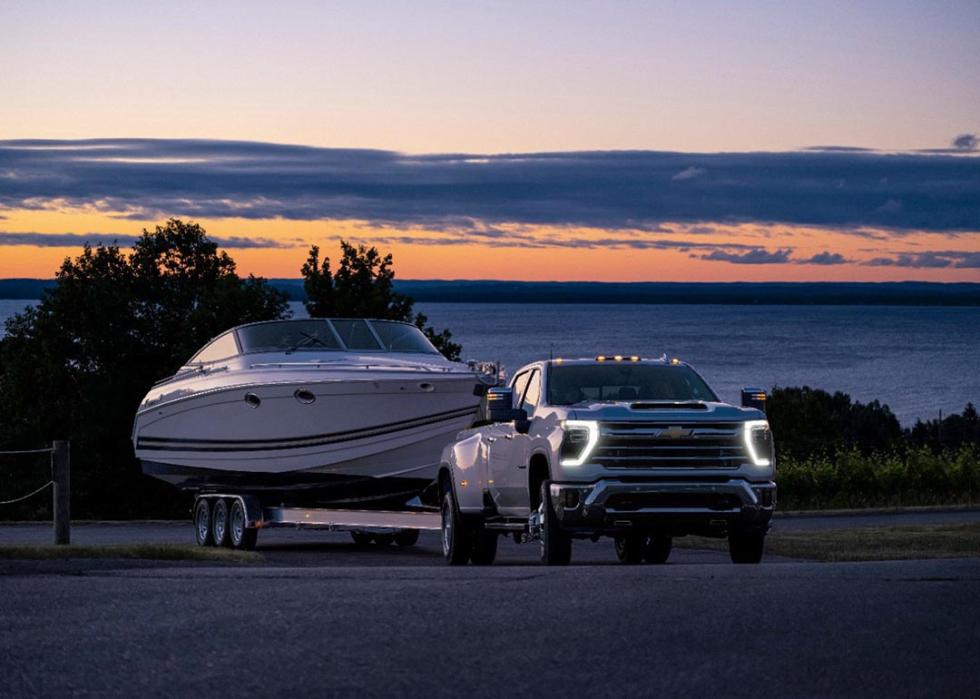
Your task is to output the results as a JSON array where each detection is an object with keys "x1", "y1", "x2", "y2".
[{"x1": 551, "y1": 478, "x2": 776, "y2": 536}]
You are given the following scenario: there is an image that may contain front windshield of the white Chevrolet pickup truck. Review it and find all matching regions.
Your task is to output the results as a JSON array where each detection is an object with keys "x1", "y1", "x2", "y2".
[{"x1": 548, "y1": 362, "x2": 718, "y2": 405}]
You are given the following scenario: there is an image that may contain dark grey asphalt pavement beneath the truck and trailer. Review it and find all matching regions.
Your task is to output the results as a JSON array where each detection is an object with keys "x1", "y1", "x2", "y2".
[{"x1": 0, "y1": 519, "x2": 980, "y2": 697}]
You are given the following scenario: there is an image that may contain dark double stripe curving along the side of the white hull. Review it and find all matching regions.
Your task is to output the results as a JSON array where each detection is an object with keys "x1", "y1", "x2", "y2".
[{"x1": 136, "y1": 406, "x2": 476, "y2": 452}]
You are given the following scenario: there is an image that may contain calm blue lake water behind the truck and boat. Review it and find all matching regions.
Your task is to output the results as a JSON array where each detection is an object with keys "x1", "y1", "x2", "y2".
[{"x1": 0, "y1": 299, "x2": 980, "y2": 424}]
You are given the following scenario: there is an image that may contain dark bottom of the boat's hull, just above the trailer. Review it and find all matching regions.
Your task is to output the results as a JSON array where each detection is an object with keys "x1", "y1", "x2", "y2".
[{"x1": 140, "y1": 461, "x2": 432, "y2": 508}]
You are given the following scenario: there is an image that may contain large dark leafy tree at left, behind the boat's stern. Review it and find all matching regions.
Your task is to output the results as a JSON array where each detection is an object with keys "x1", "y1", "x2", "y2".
[{"x1": 0, "y1": 219, "x2": 288, "y2": 517}]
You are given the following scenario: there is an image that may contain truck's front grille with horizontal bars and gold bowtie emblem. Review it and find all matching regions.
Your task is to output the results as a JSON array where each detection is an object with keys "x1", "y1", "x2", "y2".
[{"x1": 591, "y1": 422, "x2": 748, "y2": 468}]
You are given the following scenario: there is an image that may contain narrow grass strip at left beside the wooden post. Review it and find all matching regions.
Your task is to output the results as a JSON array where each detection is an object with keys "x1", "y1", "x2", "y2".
[{"x1": 0, "y1": 544, "x2": 263, "y2": 564}]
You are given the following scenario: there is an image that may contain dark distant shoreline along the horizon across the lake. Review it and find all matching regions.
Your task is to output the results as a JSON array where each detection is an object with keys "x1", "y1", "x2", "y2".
[{"x1": 0, "y1": 279, "x2": 980, "y2": 306}]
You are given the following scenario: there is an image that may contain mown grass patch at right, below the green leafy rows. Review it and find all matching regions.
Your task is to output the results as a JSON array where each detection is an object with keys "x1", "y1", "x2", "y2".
[{"x1": 676, "y1": 522, "x2": 980, "y2": 561}]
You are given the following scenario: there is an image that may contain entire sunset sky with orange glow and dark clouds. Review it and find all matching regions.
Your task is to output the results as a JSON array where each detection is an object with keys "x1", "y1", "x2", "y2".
[{"x1": 0, "y1": 0, "x2": 980, "y2": 281}]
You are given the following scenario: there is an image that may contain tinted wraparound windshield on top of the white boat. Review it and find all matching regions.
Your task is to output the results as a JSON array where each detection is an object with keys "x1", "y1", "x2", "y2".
[{"x1": 237, "y1": 318, "x2": 439, "y2": 354}]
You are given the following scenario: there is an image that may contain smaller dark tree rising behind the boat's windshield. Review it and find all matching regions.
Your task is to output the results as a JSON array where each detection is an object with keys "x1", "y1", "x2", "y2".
[{"x1": 300, "y1": 240, "x2": 463, "y2": 361}]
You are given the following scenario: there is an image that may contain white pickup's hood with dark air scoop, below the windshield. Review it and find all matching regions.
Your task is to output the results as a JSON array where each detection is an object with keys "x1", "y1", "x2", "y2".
[{"x1": 568, "y1": 401, "x2": 766, "y2": 423}]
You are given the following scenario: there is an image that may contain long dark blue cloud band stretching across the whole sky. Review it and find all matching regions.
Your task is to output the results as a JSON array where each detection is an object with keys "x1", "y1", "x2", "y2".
[{"x1": 0, "y1": 139, "x2": 980, "y2": 234}]
